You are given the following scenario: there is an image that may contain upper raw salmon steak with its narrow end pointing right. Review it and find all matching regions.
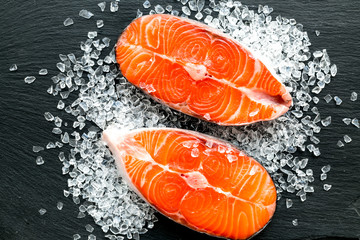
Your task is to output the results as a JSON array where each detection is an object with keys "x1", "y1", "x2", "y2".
[{"x1": 116, "y1": 14, "x2": 292, "y2": 126}]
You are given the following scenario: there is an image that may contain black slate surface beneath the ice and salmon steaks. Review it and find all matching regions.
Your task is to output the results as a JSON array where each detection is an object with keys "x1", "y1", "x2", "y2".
[{"x1": 0, "y1": 0, "x2": 360, "y2": 240}]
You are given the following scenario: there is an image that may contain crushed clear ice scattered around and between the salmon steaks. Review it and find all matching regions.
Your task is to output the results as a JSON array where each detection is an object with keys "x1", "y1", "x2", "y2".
[{"x1": 24, "y1": 0, "x2": 346, "y2": 239}]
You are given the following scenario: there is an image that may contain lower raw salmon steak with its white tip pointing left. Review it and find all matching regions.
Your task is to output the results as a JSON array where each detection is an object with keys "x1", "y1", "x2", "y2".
[{"x1": 103, "y1": 128, "x2": 276, "y2": 239}]
